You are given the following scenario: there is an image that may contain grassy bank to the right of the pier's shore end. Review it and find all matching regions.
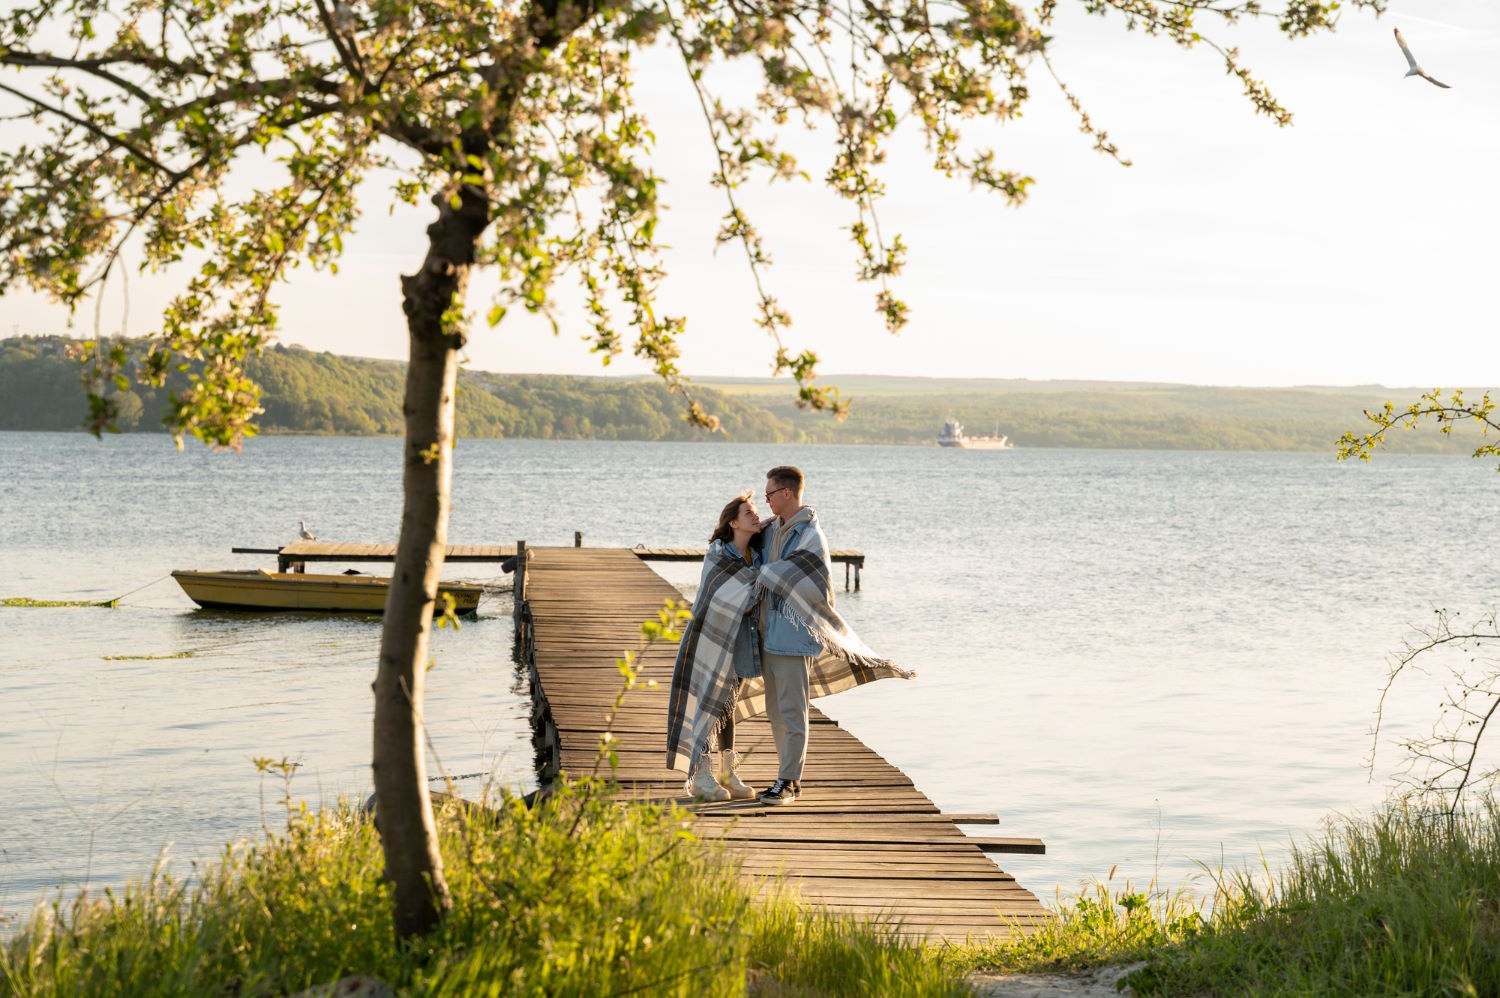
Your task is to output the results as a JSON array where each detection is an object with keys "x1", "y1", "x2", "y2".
[{"x1": 966, "y1": 798, "x2": 1500, "y2": 995}]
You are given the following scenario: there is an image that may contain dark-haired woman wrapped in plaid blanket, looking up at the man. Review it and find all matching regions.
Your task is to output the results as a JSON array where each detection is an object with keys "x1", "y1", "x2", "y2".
[{"x1": 668, "y1": 492, "x2": 764, "y2": 801}]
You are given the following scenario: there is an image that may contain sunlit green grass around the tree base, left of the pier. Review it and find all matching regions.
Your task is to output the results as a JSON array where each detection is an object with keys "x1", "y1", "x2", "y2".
[{"x1": 0, "y1": 789, "x2": 968, "y2": 996}]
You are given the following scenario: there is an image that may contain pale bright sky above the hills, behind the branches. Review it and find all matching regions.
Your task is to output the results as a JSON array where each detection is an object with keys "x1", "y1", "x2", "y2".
[{"x1": 0, "y1": 0, "x2": 1500, "y2": 387}]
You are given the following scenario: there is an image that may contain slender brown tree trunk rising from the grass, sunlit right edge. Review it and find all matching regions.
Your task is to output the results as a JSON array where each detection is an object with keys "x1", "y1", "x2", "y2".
[{"x1": 372, "y1": 184, "x2": 489, "y2": 938}]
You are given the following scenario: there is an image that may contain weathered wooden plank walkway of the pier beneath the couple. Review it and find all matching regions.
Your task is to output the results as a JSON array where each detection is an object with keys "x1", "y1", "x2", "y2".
[{"x1": 516, "y1": 545, "x2": 1049, "y2": 941}]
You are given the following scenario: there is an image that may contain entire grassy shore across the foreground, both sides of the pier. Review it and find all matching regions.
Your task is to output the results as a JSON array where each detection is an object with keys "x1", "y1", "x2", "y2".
[{"x1": 0, "y1": 789, "x2": 1500, "y2": 995}]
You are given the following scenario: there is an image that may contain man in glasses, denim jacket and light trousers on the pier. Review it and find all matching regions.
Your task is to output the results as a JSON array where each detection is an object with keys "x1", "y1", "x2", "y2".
[{"x1": 759, "y1": 465, "x2": 833, "y2": 804}]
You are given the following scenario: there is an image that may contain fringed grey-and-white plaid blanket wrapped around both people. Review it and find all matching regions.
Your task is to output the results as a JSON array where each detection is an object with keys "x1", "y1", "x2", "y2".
[{"x1": 666, "y1": 531, "x2": 917, "y2": 773}]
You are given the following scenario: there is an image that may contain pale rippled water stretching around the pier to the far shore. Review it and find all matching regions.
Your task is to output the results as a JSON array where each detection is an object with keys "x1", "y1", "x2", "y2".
[{"x1": 0, "y1": 434, "x2": 1500, "y2": 921}]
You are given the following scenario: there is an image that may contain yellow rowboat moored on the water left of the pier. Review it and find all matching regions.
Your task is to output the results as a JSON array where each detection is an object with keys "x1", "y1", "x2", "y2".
[{"x1": 173, "y1": 569, "x2": 485, "y2": 614}]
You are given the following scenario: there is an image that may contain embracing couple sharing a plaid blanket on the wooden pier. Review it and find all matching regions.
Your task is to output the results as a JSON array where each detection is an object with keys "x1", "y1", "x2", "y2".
[{"x1": 666, "y1": 465, "x2": 915, "y2": 804}]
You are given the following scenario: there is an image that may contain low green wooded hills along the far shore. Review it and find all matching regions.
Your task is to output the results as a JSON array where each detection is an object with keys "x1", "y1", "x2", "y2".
[{"x1": 0, "y1": 336, "x2": 1479, "y2": 453}]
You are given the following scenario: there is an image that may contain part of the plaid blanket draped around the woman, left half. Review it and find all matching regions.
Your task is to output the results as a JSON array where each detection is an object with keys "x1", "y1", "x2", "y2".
[{"x1": 666, "y1": 545, "x2": 765, "y2": 773}]
